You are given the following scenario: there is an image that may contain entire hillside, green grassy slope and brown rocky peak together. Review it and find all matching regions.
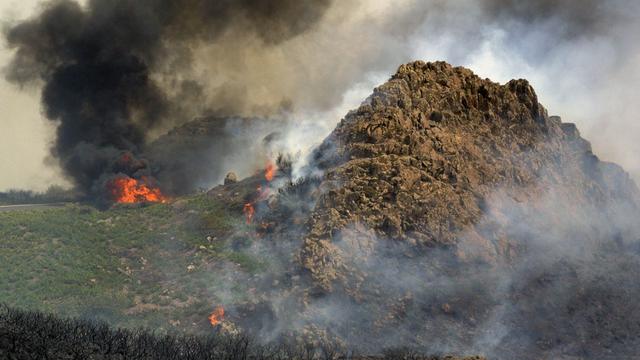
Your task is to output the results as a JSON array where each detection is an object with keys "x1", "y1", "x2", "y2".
[{"x1": 0, "y1": 62, "x2": 640, "y2": 359}]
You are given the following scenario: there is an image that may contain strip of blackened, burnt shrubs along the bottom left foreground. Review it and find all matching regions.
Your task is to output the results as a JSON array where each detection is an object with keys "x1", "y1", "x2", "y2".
[{"x1": 0, "y1": 305, "x2": 476, "y2": 360}]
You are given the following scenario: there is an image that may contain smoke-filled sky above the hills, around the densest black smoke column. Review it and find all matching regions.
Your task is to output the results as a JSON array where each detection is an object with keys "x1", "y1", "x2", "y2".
[{"x1": 0, "y1": 0, "x2": 640, "y2": 190}]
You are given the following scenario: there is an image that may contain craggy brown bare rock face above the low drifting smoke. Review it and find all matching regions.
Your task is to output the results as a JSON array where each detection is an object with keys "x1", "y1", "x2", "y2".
[{"x1": 301, "y1": 62, "x2": 640, "y2": 290}]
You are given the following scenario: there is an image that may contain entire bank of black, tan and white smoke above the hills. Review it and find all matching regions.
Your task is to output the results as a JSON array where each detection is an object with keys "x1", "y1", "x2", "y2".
[{"x1": 6, "y1": 0, "x2": 640, "y2": 194}]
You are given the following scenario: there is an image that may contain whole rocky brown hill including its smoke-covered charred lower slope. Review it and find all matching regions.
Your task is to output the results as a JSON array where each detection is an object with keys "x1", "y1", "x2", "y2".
[{"x1": 210, "y1": 62, "x2": 640, "y2": 359}]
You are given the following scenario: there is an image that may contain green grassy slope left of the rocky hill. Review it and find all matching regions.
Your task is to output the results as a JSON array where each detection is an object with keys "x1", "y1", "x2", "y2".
[{"x1": 0, "y1": 194, "x2": 262, "y2": 332}]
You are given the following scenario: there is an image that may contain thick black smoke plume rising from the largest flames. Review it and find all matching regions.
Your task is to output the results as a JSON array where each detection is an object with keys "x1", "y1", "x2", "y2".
[{"x1": 5, "y1": 0, "x2": 329, "y2": 199}]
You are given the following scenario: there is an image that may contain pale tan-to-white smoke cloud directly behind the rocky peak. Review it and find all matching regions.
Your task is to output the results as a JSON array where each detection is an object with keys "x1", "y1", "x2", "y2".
[{"x1": 162, "y1": 0, "x2": 640, "y2": 191}]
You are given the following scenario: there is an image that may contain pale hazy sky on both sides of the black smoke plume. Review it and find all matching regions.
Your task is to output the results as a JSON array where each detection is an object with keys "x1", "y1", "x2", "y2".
[{"x1": 0, "y1": 0, "x2": 640, "y2": 190}]
